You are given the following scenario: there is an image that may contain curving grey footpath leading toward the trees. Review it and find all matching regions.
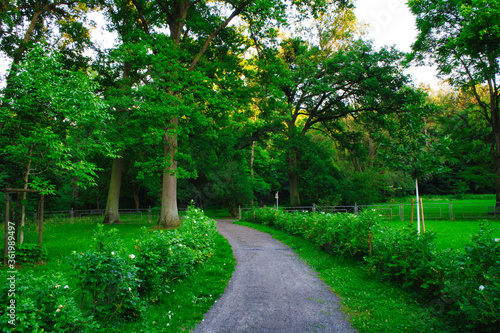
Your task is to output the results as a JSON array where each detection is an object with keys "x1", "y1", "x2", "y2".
[{"x1": 194, "y1": 220, "x2": 356, "y2": 333}]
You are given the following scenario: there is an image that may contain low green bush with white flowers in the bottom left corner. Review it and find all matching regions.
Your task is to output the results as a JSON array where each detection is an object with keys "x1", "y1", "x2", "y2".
[{"x1": 0, "y1": 271, "x2": 99, "y2": 333}]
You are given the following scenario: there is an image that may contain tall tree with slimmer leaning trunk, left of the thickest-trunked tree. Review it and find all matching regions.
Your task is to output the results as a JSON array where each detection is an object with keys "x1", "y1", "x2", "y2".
[{"x1": 98, "y1": 1, "x2": 148, "y2": 223}]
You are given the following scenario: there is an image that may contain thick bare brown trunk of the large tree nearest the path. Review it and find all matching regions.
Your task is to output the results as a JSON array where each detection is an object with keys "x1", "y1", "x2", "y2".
[{"x1": 159, "y1": 117, "x2": 181, "y2": 227}]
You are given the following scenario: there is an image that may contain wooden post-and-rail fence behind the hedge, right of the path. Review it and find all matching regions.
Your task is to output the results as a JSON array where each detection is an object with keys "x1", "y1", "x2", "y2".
[{"x1": 239, "y1": 202, "x2": 500, "y2": 221}]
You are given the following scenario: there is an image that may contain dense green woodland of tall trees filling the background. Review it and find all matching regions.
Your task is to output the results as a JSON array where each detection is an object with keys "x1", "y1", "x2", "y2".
[{"x1": 0, "y1": 0, "x2": 500, "y2": 226}]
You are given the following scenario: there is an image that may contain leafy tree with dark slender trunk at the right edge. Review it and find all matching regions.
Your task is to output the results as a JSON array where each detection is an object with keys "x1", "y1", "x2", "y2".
[{"x1": 408, "y1": 0, "x2": 500, "y2": 206}]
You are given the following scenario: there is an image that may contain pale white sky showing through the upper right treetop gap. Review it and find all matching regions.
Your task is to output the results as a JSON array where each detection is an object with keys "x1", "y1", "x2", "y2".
[{"x1": 355, "y1": 0, "x2": 439, "y2": 89}]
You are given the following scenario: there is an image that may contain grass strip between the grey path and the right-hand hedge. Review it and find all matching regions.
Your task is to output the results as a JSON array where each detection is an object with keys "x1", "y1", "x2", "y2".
[{"x1": 236, "y1": 221, "x2": 453, "y2": 333}]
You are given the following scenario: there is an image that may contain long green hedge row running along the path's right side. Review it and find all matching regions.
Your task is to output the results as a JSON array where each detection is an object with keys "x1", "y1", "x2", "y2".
[{"x1": 245, "y1": 208, "x2": 500, "y2": 332}]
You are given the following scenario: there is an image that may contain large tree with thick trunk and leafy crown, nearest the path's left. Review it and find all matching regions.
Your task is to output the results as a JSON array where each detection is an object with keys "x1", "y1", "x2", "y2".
[{"x1": 122, "y1": 0, "x2": 340, "y2": 226}]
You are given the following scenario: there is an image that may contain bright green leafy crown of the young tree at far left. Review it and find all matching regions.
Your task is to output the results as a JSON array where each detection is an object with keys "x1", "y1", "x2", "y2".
[{"x1": 0, "y1": 46, "x2": 113, "y2": 228}]
